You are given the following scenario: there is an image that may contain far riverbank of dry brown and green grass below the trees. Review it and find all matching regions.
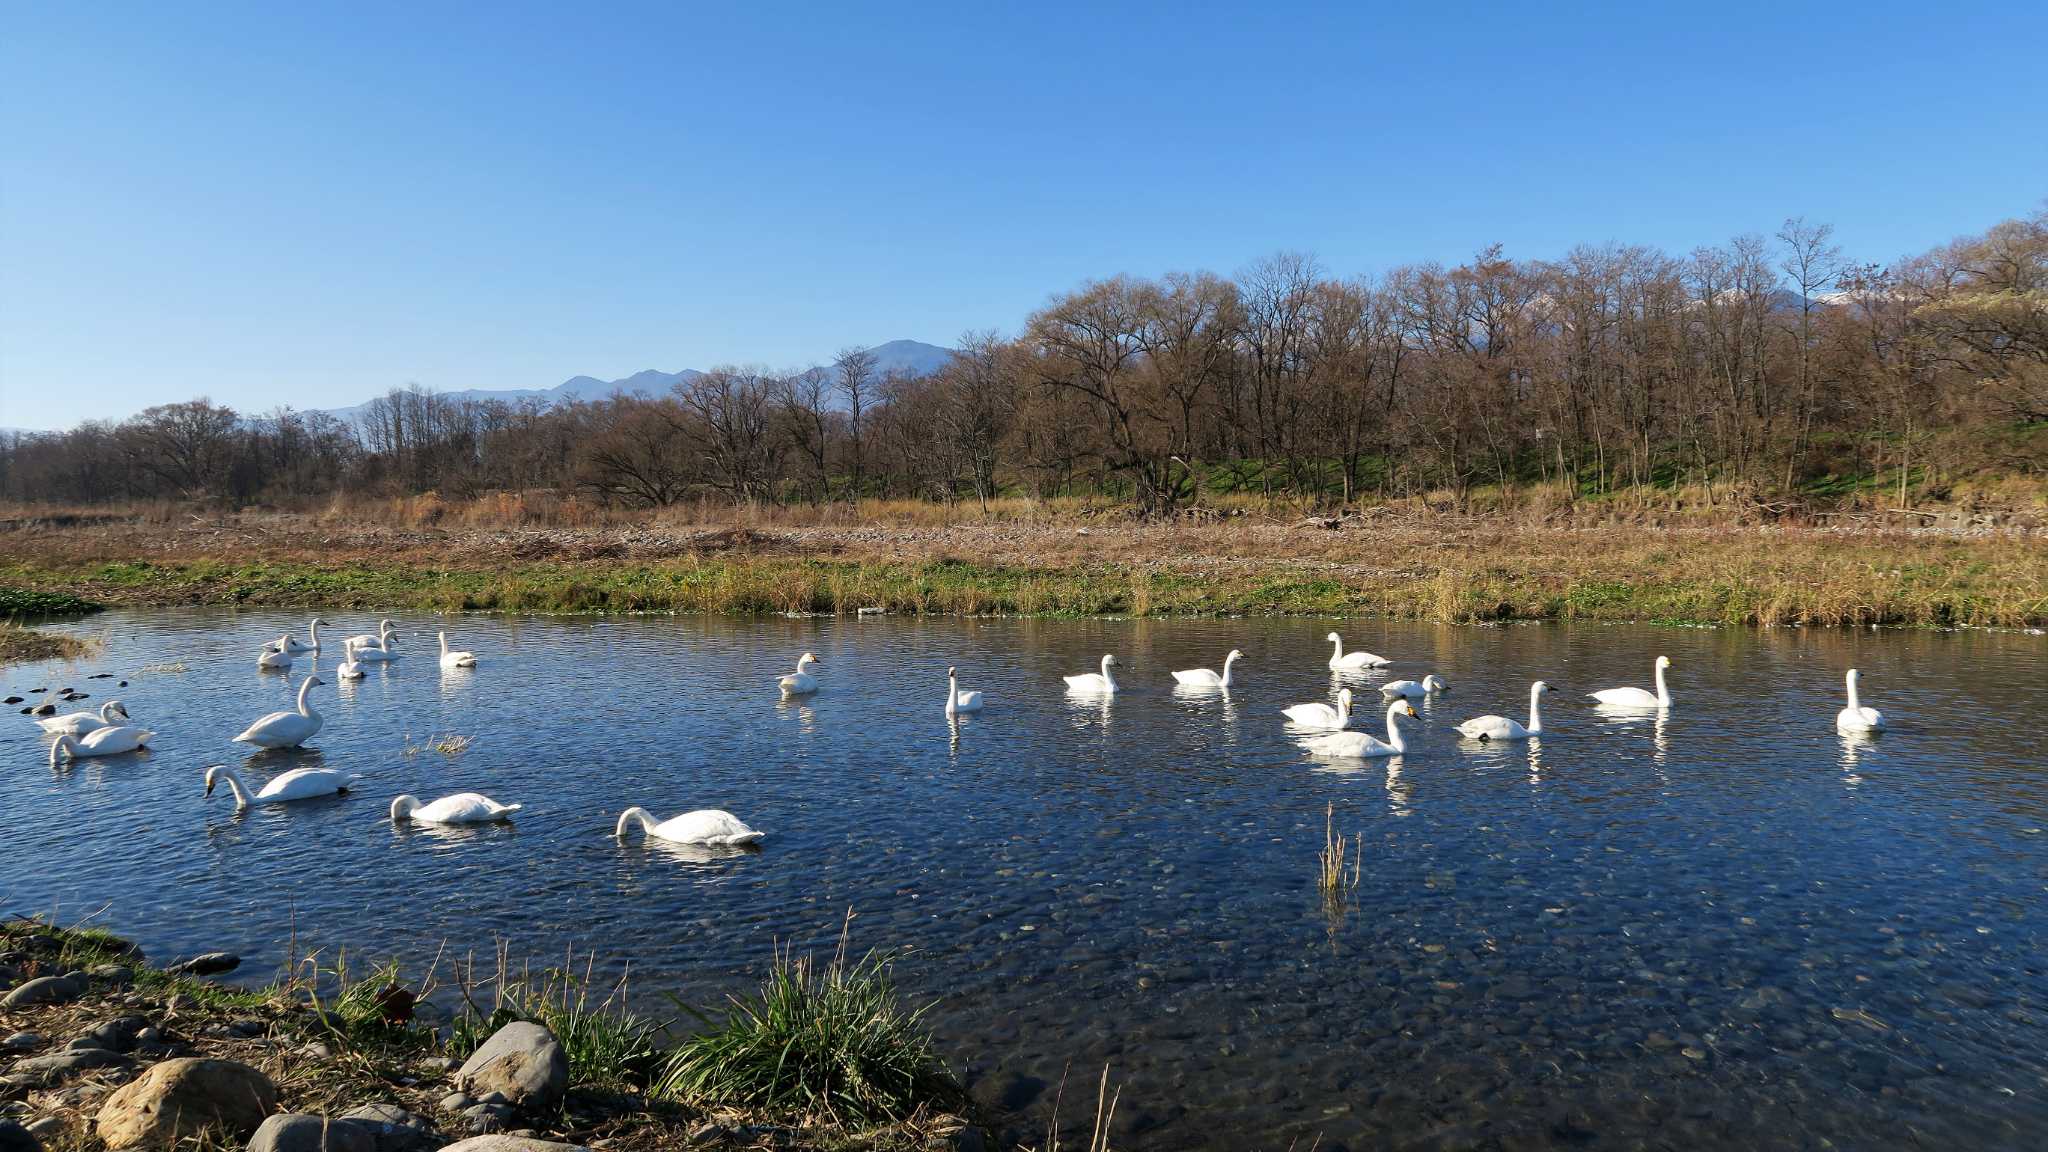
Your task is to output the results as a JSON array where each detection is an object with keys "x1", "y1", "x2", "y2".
[{"x1": 0, "y1": 508, "x2": 2048, "y2": 627}]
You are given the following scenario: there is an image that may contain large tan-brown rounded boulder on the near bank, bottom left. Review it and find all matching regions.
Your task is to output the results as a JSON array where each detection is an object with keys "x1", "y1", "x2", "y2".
[{"x1": 86, "y1": 1050, "x2": 276, "y2": 1148}]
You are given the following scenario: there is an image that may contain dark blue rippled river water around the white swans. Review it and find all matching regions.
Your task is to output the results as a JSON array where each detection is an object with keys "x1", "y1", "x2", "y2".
[{"x1": 0, "y1": 611, "x2": 2048, "y2": 1148}]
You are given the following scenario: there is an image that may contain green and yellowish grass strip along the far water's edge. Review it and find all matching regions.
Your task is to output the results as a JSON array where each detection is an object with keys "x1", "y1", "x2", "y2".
[{"x1": 0, "y1": 539, "x2": 2048, "y2": 627}]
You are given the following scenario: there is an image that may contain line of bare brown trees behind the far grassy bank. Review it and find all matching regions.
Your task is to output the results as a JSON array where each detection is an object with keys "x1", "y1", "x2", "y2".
[{"x1": 0, "y1": 209, "x2": 2048, "y2": 512}]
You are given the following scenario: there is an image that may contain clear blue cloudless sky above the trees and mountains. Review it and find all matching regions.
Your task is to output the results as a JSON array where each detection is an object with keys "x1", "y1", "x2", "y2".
[{"x1": 0, "y1": 0, "x2": 2048, "y2": 426}]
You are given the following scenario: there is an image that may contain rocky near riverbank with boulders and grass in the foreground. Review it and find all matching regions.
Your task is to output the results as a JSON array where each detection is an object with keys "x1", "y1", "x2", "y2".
[{"x1": 0, "y1": 920, "x2": 989, "y2": 1152}]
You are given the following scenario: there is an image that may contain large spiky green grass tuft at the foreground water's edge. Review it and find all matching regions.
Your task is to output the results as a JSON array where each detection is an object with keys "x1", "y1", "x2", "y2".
[{"x1": 655, "y1": 918, "x2": 967, "y2": 1123}]
